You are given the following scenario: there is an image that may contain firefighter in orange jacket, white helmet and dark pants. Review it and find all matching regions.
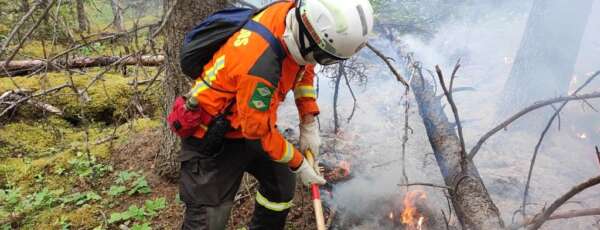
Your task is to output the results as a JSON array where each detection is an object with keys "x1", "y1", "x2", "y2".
[{"x1": 180, "y1": 0, "x2": 373, "y2": 230}]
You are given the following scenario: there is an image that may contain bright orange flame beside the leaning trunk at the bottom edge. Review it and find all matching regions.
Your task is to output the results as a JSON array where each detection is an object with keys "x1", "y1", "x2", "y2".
[{"x1": 401, "y1": 191, "x2": 427, "y2": 230}]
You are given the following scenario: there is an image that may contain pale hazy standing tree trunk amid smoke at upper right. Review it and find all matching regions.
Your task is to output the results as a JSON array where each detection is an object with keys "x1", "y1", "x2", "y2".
[{"x1": 502, "y1": 0, "x2": 594, "y2": 113}]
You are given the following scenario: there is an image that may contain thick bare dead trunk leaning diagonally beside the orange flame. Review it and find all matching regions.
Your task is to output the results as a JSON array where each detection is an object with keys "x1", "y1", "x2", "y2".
[{"x1": 411, "y1": 63, "x2": 504, "y2": 229}]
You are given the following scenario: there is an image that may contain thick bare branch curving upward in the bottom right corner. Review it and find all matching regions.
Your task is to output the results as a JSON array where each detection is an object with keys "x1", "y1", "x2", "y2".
[{"x1": 528, "y1": 176, "x2": 600, "y2": 230}]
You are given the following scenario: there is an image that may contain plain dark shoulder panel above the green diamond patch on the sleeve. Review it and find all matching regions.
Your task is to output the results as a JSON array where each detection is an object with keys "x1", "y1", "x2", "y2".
[{"x1": 249, "y1": 47, "x2": 282, "y2": 87}]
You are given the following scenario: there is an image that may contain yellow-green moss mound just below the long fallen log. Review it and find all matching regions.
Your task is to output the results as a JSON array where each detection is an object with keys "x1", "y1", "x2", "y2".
[{"x1": 0, "y1": 68, "x2": 159, "y2": 123}]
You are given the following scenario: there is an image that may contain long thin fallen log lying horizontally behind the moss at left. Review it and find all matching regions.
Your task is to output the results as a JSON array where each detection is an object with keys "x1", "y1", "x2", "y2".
[{"x1": 0, "y1": 55, "x2": 165, "y2": 77}]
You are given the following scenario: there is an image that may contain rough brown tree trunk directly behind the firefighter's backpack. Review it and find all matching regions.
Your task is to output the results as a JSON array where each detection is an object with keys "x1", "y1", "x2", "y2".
[{"x1": 156, "y1": 0, "x2": 227, "y2": 179}]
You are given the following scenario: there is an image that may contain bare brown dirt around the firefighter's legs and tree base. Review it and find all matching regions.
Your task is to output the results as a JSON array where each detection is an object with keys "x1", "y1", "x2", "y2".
[{"x1": 111, "y1": 130, "x2": 329, "y2": 229}]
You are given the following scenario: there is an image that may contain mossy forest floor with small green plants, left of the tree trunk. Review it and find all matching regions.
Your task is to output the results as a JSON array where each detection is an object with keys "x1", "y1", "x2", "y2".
[{"x1": 0, "y1": 68, "x2": 181, "y2": 229}]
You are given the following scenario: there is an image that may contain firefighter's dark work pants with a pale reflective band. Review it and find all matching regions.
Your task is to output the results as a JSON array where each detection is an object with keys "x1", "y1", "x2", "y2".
[{"x1": 179, "y1": 138, "x2": 296, "y2": 230}]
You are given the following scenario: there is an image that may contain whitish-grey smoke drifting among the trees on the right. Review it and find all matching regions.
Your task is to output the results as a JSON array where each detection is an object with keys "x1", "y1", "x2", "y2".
[{"x1": 279, "y1": 0, "x2": 600, "y2": 229}]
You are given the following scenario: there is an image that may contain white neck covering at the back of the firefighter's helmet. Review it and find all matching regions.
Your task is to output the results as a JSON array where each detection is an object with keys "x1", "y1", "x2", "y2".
[{"x1": 283, "y1": 10, "x2": 316, "y2": 65}]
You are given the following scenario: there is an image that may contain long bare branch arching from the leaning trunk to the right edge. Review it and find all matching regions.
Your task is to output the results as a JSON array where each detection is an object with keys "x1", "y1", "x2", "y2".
[{"x1": 469, "y1": 91, "x2": 600, "y2": 160}]
